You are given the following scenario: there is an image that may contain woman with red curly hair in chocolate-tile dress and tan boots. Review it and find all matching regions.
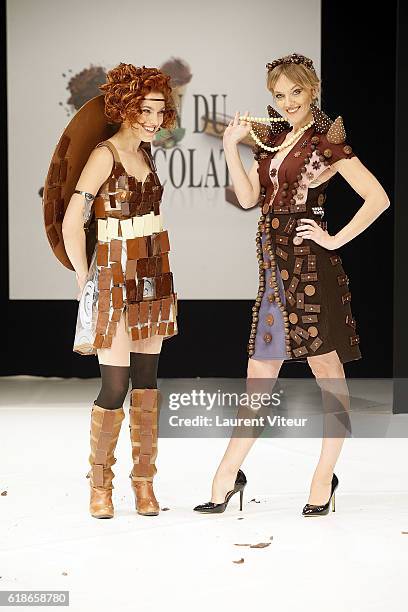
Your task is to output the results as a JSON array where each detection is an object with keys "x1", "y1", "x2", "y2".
[{"x1": 62, "y1": 63, "x2": 177, "y2": 518}]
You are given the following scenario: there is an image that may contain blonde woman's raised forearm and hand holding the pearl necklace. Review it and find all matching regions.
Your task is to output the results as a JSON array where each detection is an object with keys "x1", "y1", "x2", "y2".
[{"x1": 223, "y1": 111, "x2": 261, "y2": 208}]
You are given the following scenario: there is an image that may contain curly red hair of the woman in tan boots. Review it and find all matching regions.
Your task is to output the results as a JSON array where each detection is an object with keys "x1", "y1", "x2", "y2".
[{"x1": 99, "y1": 63, "x2": 176, "y2": 128}]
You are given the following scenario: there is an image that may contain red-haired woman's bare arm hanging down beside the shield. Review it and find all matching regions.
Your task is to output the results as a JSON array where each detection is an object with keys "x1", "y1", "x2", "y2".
[{"x1": 62, "y1": 147, "x2": 112, "y2": 293}]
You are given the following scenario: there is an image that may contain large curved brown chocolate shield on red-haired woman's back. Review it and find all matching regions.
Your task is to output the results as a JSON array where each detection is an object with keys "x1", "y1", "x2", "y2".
[{"x1": 42, "y1": 94, "x2": 151, "y2": 270}]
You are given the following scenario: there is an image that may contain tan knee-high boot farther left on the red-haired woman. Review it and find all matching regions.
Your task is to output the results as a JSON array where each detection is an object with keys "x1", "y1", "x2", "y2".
[{"x1": 86, "y1": 404, "x2": 125, "y2": 518}]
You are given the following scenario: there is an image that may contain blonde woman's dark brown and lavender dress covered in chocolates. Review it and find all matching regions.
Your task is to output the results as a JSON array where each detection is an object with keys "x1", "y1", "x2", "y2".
[{"x1": 248, "y1": 111, "x2": 361, "y2": 363}]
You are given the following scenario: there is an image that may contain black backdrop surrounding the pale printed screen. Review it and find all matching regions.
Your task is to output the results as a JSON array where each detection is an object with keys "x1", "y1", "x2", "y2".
[{"x1": 0, "y1": 0, "x2": 402, "y2": 378}]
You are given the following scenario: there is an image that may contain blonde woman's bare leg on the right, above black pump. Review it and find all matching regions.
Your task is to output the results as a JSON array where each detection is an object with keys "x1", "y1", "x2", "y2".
[{"x1": 308, "y1": 351, "x2": 350, "y2": 505}]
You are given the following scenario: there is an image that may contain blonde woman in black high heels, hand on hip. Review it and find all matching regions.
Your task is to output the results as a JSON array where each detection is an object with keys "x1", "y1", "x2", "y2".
[{"x1": 194, "y1": 53, "x2": 389, "y2": 516}]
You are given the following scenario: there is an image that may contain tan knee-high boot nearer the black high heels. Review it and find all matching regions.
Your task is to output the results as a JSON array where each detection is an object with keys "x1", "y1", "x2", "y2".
[{"x1": 129, "y1": 389, "x2": 159, "y2": 516}]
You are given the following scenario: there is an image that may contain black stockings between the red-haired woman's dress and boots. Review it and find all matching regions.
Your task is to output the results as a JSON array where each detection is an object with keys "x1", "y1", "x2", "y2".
[{"x1": 95, "y1": 353, "x2": 160, "y2": 410}]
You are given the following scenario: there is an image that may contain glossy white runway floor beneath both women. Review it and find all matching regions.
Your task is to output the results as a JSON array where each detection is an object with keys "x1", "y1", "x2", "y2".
[{"x1": 0, "y1": 377, "x2": 408, "y2": 612}]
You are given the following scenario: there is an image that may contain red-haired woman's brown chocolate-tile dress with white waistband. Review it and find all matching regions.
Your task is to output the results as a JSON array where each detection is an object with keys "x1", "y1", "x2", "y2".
[{"x1": 74, "y1": 141, "x2": 177, "y2": 355}]
